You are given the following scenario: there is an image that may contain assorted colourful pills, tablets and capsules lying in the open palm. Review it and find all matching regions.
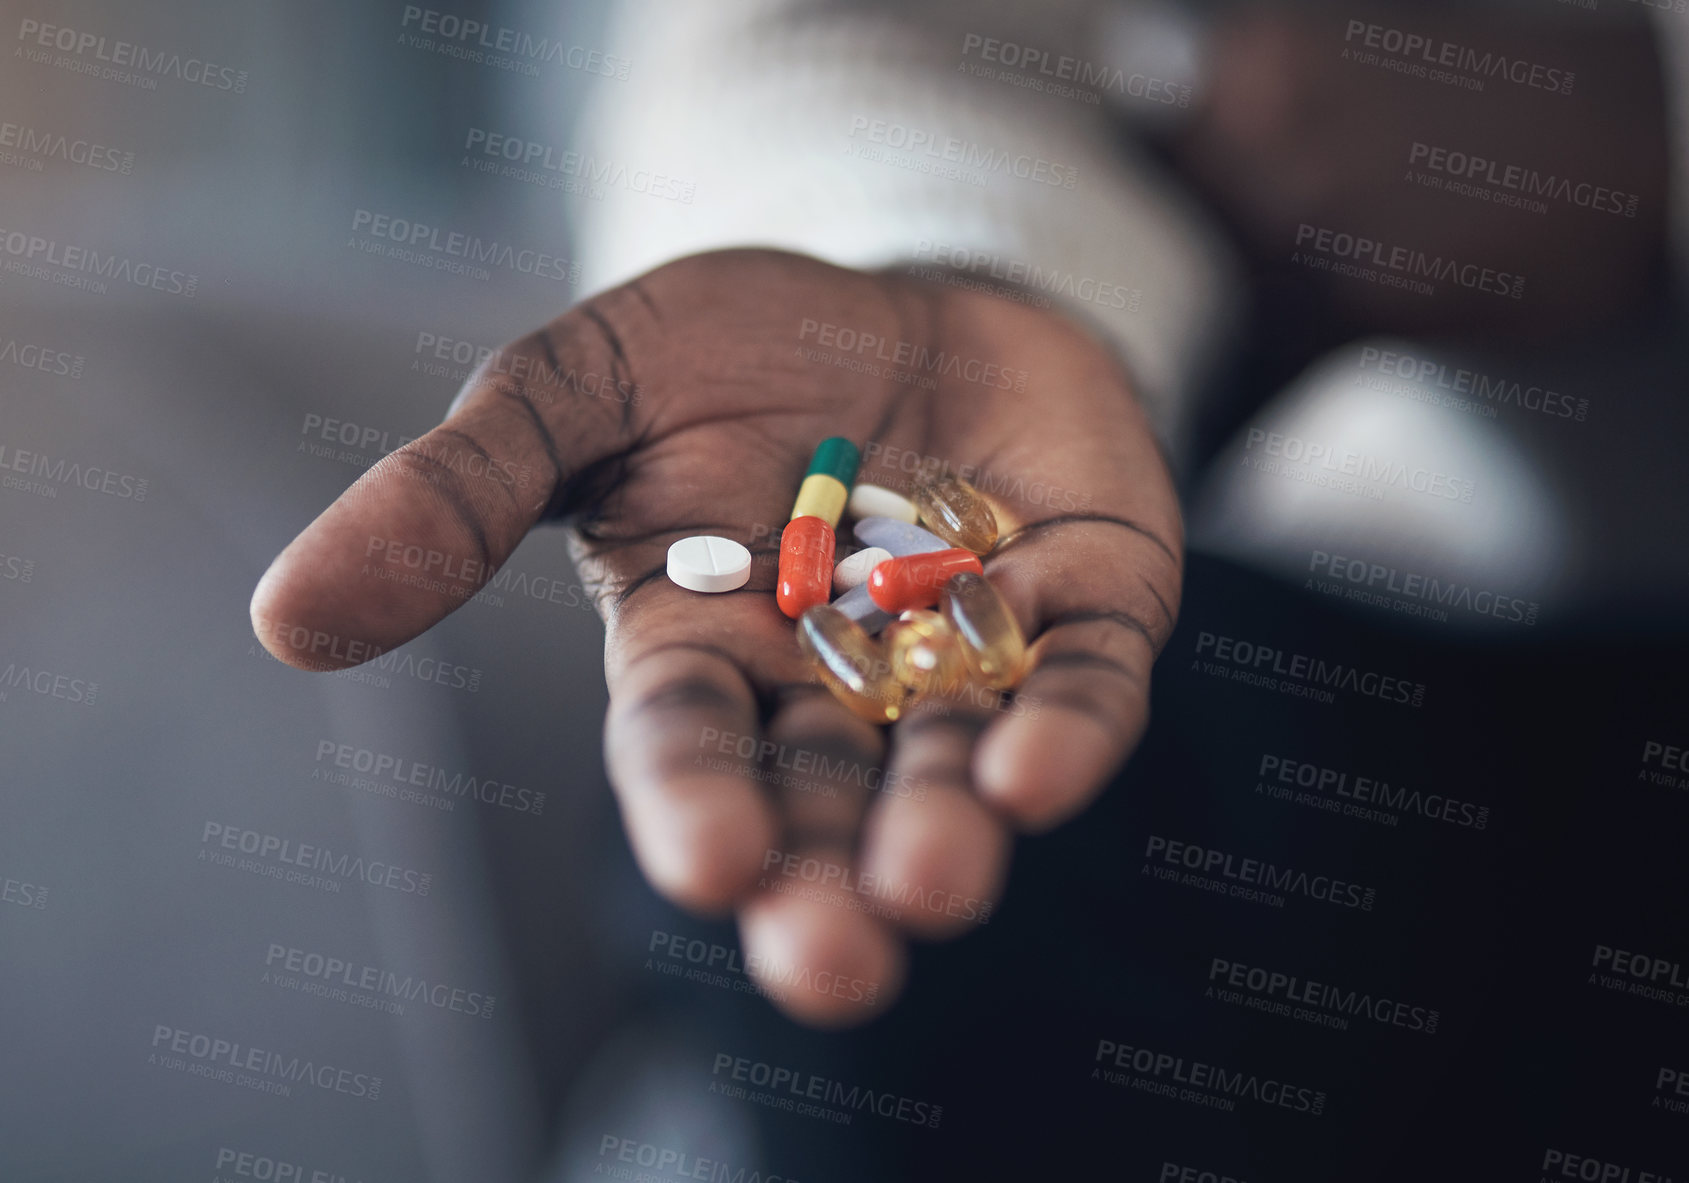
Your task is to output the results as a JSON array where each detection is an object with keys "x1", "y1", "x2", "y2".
[{"x1": 669, "y1": 436, "x2": 1027, "y2": 723}]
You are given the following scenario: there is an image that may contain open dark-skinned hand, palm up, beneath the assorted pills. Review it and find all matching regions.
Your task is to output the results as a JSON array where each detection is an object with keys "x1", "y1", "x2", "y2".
[{"x1": 252, "y1": 250, "x2": 1182, "y2": 1026}]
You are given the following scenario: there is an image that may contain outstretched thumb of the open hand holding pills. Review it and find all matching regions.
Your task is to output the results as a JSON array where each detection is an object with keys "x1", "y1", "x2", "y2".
[{"x1": 252, "y1": 309, "x2": 633, "y2": 669}]
